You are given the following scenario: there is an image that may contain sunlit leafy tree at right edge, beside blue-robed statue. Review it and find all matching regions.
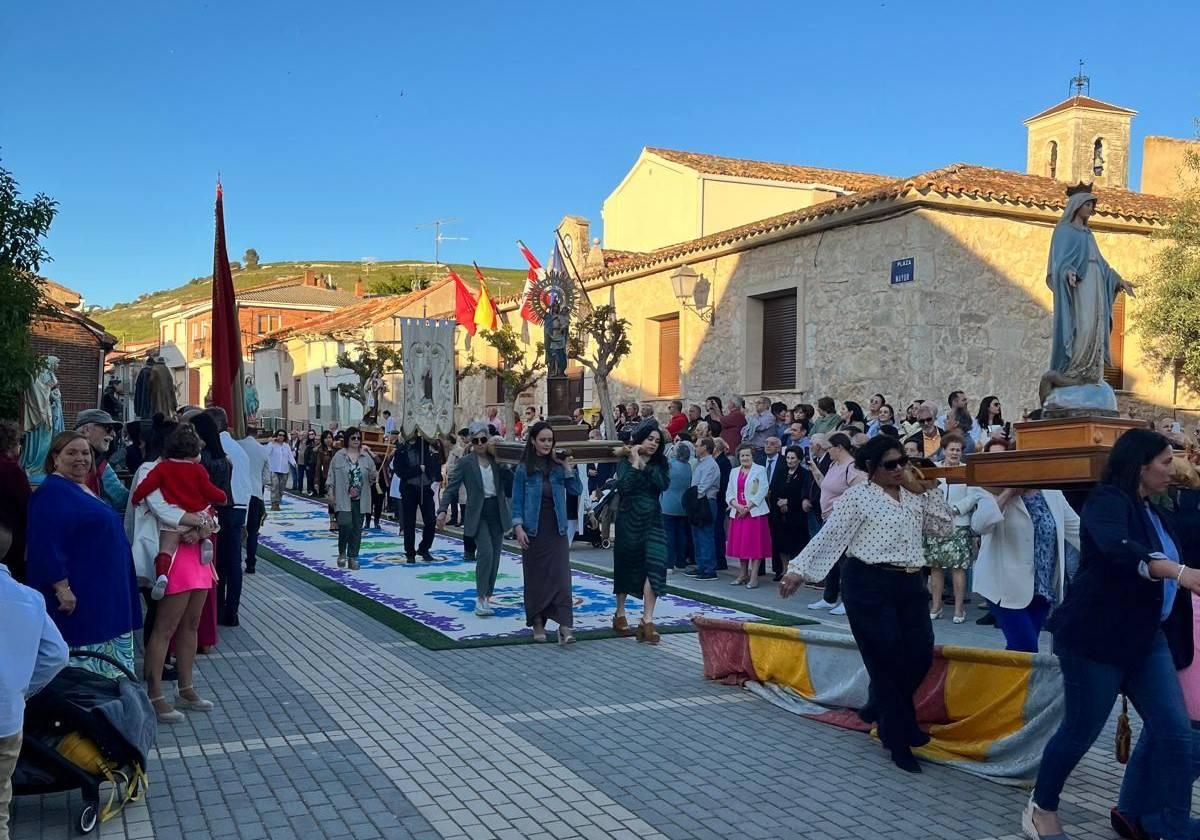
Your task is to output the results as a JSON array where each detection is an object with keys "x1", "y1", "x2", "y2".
[{"x1": 1133, "y1": 143, "x2": 1200, "y2": 391}]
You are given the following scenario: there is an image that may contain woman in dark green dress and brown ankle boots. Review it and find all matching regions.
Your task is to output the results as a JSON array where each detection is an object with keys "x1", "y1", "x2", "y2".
[{"x1": 612, "y1": 427, "x2": 671, "y2": 644}]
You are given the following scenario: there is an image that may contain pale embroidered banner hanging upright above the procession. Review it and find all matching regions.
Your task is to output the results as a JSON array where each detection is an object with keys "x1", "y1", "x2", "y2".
[{"x1": 400, "y1": 318, "x2": 455, "y2": 440}]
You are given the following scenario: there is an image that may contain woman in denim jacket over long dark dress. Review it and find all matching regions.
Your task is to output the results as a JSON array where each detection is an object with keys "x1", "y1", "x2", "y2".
[{"x1": 511, "y1": 421, "x2": 583, "y2": 644}]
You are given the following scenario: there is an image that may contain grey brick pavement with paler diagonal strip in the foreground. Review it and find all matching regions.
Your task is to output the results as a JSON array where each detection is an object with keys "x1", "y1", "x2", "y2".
[{"x1": 13, "y1": 542, "x2": 1161, "y2": 840}]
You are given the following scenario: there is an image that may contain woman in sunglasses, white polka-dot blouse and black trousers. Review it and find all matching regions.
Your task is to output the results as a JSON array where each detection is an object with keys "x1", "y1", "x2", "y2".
[{"x1": 779, "y1": 436, "x2": 954, "y2": 773}]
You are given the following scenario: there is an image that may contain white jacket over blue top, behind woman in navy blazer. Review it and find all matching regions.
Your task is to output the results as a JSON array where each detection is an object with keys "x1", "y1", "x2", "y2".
[{"x1": 971, "y1": 490, "x2": 1079, "y2": 610}]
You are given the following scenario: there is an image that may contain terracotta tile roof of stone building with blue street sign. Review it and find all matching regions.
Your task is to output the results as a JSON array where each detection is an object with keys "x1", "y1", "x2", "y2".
[{"x1": 584, "y1": 163, "x2": 1172, "y2": 280}]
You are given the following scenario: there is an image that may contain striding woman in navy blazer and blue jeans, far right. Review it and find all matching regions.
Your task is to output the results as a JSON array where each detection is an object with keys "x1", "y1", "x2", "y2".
[{"x1": 1021, "y1": 428, "x2": 1200, "y2": 840}]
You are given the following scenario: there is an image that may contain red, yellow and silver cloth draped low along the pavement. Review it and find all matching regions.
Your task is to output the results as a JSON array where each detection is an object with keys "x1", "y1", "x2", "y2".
[{"x1": 692, "y1": 617, "x2": 1063, "y2": 785}]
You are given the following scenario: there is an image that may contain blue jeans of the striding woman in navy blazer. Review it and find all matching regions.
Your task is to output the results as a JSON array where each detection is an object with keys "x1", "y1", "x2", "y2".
[{"x1": 1033, "y1": 629, "x2": 1193, "y2": 840}]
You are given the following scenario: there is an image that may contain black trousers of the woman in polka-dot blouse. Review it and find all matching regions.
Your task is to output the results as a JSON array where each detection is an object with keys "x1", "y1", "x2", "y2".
[{"x1": 841, "y1": 557, "x2": 934, "y2": 752}]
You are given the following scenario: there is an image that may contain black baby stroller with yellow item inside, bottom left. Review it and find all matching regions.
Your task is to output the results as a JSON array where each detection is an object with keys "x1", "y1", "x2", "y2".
[{"x1": 12, "y1": 650, "x2": 157, "y2": 834}]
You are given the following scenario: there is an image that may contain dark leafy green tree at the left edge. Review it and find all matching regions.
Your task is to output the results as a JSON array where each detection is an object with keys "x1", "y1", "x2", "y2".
[{"x1": 0, "y1": 159, "x2": 59, "y2": 421}]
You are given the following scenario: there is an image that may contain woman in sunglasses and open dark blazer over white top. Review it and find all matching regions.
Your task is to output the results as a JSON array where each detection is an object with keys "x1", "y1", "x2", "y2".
[{"x1": 438, "y1": 422, "x2": 512, "y2": 617}]
